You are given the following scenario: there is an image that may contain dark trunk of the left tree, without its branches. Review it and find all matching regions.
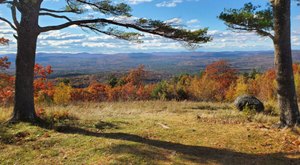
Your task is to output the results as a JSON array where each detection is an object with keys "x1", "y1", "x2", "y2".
[{"x1": 12, "y1": 0, "x2": 41, "y2": 122}]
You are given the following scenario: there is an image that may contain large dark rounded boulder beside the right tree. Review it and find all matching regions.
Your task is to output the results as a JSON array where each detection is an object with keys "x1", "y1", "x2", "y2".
[{"x1": 234, "y1": 95, "x2": 265, "y2": 112}]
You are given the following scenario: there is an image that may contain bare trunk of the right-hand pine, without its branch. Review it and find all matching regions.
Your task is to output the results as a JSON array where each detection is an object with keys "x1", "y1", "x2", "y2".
[{"x1": 273, "y1": 0, "x2": 299, "y2": 127}]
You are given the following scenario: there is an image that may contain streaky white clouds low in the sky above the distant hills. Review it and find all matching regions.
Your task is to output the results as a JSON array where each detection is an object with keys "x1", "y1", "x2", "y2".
[{"x1": 0, "y1": 18, "x2": 300, "y2": 54}]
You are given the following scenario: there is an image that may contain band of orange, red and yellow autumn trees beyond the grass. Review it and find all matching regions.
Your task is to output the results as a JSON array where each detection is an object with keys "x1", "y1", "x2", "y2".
[{"x1": 0, "y1": 57, "x2": 300, "y2": 105}]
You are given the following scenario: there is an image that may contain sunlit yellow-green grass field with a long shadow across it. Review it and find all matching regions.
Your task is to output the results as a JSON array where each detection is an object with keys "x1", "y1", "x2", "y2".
[{"x1": 0, "y1": 101, "x2": 300, "y2": 165}]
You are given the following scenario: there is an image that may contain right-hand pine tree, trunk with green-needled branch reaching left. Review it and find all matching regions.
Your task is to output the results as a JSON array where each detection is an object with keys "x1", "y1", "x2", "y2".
[{"x1": 219, "y1": 0, "x2": 300, "y2": 127}]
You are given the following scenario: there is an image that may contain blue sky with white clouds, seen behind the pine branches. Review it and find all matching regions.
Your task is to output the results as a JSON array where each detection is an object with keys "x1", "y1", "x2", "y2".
[{"x1": 0, "y1": 0, "x2": 300, "y2": 53}]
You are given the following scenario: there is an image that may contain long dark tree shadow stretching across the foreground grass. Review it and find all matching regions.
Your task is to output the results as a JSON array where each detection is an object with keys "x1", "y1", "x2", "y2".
[{"x1": 56, "y1": 126, "x2": 300, "y2": 165}]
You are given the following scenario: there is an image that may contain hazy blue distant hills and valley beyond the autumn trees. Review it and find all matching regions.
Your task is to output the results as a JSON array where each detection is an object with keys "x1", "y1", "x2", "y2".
[{"x1": 2, "y1": 51, "x2": 300, "y2": 75}]
